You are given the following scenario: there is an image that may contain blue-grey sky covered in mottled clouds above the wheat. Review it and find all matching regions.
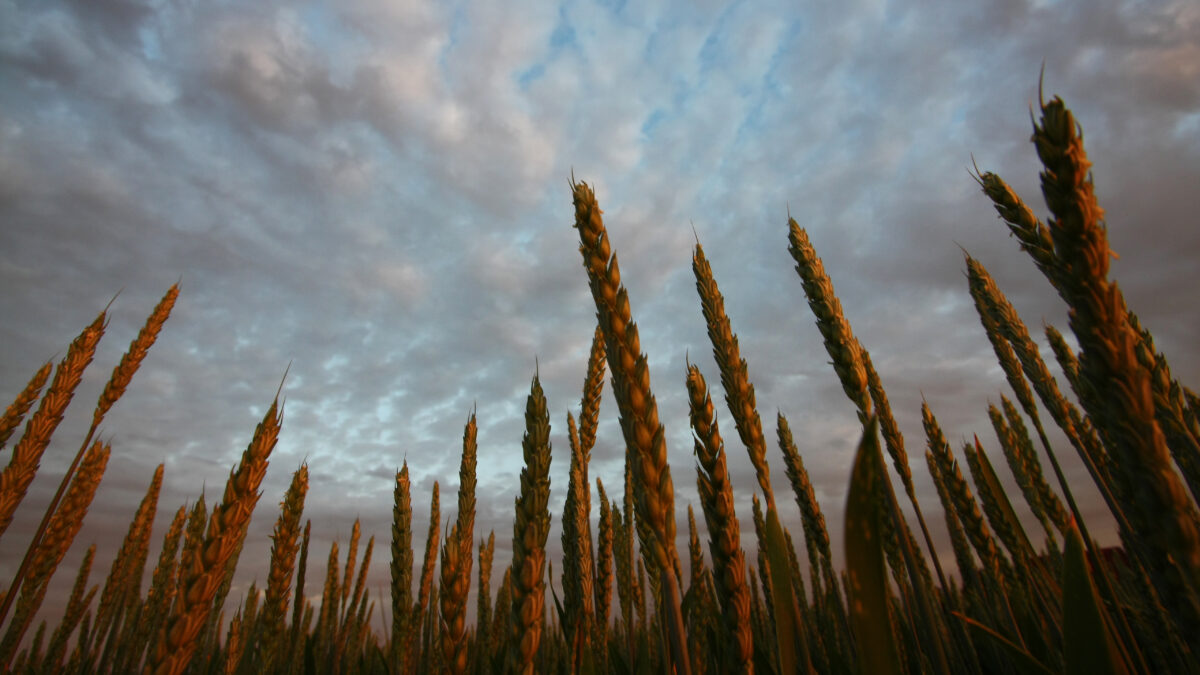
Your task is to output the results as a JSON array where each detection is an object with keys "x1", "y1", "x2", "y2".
[{"x1": 0, "y1": 0, "x2": 1200, "y2": 629}]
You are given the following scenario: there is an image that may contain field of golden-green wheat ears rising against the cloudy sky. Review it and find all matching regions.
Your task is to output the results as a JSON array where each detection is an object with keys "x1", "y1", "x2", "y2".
[{"x1": 0, "y1": 90, "x2": 1200, "y2": 675}]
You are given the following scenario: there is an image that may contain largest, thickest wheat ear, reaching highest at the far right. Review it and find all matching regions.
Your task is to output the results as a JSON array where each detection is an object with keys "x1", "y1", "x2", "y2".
[{"x1": 1033, "y1": 97, "x2": 1200, "y2": 626}]
